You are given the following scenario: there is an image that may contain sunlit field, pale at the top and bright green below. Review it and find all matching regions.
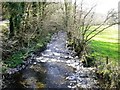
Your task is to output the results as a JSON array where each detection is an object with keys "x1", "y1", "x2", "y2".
[{"x1": 91, "y1": 26, "x2": 118, "y2": 61}]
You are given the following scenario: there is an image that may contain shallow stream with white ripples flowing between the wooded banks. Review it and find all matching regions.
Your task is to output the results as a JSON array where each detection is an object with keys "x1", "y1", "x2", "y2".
[{"x1": 3, "y1": 31, "x2": 98, "y2": 90}]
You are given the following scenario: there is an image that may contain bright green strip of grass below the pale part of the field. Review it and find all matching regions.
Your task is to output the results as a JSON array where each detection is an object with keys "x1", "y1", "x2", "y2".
[{"x1": 91, "y1": 40, "x2": 118, "y2": 60}]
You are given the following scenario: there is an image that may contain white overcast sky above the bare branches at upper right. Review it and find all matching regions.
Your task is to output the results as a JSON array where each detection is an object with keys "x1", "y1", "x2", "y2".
[{"x1": 72, "y1": 0, "x2": 120, "y2": 14}]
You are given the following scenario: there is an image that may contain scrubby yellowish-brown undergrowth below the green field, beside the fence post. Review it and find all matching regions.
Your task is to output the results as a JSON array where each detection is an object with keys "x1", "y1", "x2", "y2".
[{"x1": 95, "y1": 58, "x2": 120, "y2": 88}]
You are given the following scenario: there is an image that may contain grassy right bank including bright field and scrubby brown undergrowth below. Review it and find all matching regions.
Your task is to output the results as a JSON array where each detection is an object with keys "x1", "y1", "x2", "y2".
[{"x1": 90, "y1": 26, "x2": 120, "y2": 89}]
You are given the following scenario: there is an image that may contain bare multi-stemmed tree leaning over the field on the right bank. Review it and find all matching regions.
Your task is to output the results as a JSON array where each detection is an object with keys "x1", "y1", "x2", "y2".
[{"x1": 68, "y1": 0, "x2": 119, "y2": 58}]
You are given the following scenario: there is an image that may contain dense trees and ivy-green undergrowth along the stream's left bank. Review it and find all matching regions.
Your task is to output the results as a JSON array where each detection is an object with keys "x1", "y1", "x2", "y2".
[{"x1": 2, "y1": 2, "x2": 62, "y2": 71}]
